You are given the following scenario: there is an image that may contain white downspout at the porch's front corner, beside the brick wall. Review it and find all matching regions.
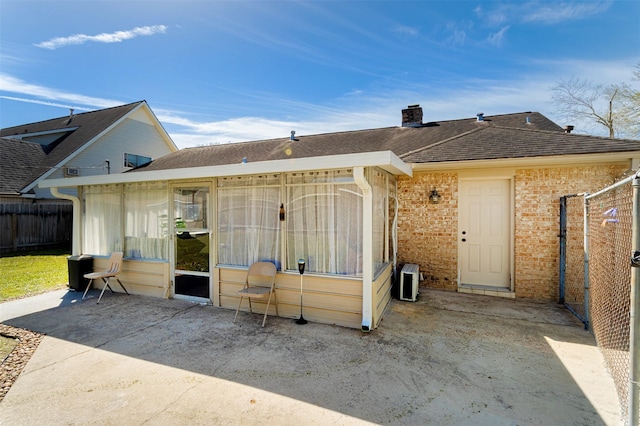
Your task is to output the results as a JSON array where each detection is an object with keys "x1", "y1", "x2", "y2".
[{"x1": 353, "y1": 167, "x2": 373, "y2": 333}]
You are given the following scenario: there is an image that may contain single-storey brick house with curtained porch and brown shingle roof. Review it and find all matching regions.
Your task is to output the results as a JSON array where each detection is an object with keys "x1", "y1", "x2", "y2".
[{"x1": 37, "y1": 105, "x2": 640, "y2": 331}]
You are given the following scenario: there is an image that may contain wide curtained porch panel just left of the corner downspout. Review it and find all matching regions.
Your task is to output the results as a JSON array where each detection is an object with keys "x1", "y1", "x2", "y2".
[{"x1": 287, "y1": 170, "x2": 362, "y2": 276}]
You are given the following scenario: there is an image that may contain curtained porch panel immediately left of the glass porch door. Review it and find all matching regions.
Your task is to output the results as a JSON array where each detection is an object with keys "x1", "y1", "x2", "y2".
[{"x1": 124, "y1": 182, "x2": 169, "y2": 260}]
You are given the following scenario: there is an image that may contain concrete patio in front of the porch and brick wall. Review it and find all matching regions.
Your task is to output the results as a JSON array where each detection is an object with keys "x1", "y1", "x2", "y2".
[{"x1": 0, "y1": 289, "x2": 621, "y2": 425}]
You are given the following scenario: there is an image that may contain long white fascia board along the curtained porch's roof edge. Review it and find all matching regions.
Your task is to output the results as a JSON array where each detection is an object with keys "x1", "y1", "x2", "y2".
[{"x1": 39, "y1": 151, "x2": 412, "y2": 188}]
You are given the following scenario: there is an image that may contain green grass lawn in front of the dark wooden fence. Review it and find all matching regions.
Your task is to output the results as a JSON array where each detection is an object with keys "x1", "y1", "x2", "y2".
[{"x1": 0, "y1": 250, "x2": 69, "y2": 302}]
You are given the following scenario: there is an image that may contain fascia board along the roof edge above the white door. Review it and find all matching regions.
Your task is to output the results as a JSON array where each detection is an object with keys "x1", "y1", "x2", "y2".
[{"x1": 412, "y1": 151, "x2": 640, "y2": 172}]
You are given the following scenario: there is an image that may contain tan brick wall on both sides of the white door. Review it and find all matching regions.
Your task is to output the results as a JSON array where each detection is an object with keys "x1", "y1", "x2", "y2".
[{"x1": 398, "y1": 165, "x2": 627, "y2": 300}]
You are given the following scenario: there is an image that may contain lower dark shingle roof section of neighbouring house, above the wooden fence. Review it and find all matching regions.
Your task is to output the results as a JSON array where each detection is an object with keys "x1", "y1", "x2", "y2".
[{"x1": 0, "y1": 138, "x2": 46, "y2": 195}]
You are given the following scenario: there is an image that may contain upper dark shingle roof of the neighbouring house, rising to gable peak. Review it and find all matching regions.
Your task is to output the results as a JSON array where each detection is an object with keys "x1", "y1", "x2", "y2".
[{"x1": 0, "y1": 101, "x2": 144, "y2": 190}]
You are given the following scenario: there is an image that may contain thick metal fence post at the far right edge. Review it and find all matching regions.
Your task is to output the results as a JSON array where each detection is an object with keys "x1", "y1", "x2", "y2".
[{"x1": 628, "y1": 174, "x2": 640, "y2": 426}]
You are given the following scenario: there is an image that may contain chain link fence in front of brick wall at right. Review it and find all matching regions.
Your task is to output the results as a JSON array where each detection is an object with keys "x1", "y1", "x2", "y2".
[{"x1": 560, "y1": 178, "x2": 640, "y2": 418}]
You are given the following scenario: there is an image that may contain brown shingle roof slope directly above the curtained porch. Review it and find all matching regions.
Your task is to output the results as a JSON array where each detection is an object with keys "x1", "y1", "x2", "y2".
[{"x1": 134, "y1": 112, "x2": 562, "y2": 172}]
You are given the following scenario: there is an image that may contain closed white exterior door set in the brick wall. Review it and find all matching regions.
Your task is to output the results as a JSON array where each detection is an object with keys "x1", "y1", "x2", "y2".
[{"x1": 458, "y1": 179, "x2": 511, "y2": 289}]
